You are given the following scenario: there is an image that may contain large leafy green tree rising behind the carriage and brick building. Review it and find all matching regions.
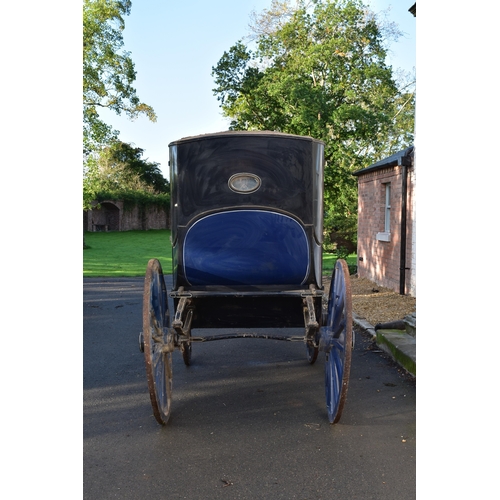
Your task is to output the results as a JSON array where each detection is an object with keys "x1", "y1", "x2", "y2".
[{"x1": 212, "y1": 0, "x2": 414, "y2": 250}]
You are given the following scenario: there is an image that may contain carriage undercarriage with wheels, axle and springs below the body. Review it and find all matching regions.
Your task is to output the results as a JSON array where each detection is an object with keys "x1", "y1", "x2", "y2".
[{"x1": 139, "y1": 259, "x2": 354, "y2": 425}]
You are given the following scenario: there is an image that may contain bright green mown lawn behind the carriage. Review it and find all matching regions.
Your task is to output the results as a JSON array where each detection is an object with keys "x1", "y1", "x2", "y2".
[{"x1": 83, "y1": 229, "x2": 356, "y2": 278}]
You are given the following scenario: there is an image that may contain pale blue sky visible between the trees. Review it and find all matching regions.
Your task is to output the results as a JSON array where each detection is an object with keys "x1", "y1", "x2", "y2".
[{"x1": 101, "y1": 0, "x2": 416, "y2": 178}]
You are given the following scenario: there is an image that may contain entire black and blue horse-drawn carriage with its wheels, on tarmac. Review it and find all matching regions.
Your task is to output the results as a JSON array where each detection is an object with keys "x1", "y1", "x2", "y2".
[{"x1": 140, "y1": 132, "x2": 353, "y2": 424}]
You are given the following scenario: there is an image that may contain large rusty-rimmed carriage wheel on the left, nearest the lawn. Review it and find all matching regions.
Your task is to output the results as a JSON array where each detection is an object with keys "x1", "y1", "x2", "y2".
[{"x1": 142, "y1": 259, "x2": 173, "y2": 425}]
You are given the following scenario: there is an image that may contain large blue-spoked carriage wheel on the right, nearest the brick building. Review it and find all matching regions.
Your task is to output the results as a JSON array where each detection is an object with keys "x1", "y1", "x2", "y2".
[{"x1": 322, "y1": 259, "x2": 353, "y2": 424}]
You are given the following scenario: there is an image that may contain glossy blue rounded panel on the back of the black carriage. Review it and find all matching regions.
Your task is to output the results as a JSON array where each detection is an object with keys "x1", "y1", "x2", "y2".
[{"x1": 183, "y1": 210, "x2": 310, "y2": 286}]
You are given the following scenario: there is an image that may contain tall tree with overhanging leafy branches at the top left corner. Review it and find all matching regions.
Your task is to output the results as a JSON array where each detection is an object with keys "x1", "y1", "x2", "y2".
[{"x1": 83, "y1": 0, "x2": 156, "y2": 154}]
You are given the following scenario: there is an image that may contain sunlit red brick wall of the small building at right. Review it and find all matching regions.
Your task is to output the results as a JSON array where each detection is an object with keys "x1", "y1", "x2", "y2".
[{"x1": 358, "y1": 166, "x2": 413, "y2": 294}]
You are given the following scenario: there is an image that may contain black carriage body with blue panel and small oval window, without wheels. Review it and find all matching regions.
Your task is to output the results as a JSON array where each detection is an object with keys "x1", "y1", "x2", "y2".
[{"x1": 169, "y1": 132, "x2": 324, "y2": 328}]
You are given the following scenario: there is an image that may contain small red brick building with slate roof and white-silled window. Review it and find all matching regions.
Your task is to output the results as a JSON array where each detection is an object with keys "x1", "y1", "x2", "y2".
[{"x1": 354, "y1": 147, "x2": 416, "y2": 296}]
